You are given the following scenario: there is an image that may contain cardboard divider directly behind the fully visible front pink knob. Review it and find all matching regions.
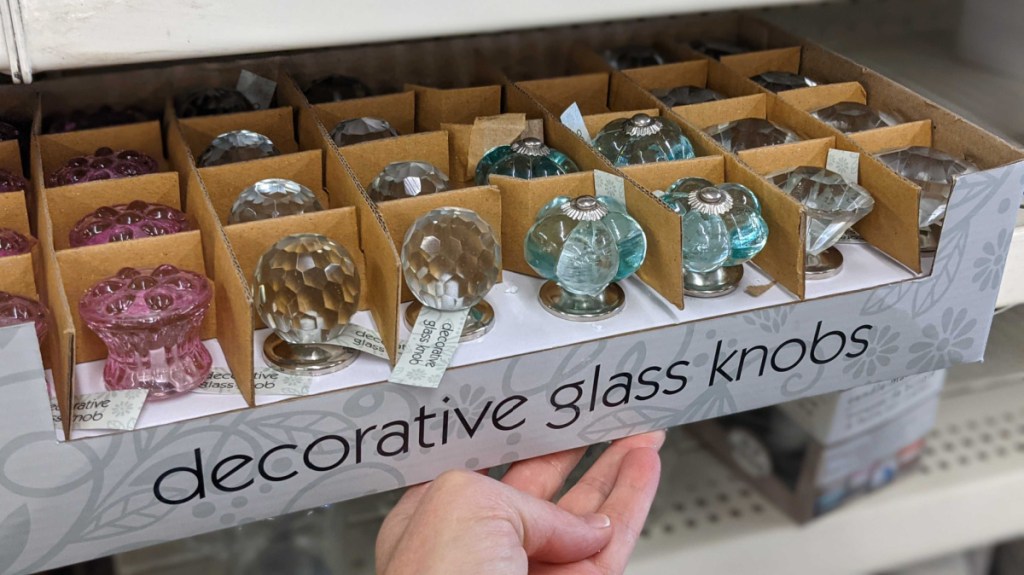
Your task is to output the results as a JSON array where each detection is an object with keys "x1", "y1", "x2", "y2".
[{"x1": 56, "y1": 230, "x2": 216, "y2": 362}]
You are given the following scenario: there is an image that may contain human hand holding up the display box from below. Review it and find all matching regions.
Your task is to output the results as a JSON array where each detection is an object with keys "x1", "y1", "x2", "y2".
[{"x1": 377, "y1": 432, "x2": 665, "y2": 575}]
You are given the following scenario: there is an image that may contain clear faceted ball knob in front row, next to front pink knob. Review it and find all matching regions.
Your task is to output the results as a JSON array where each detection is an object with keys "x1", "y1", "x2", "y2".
[{"x1": 255, "y1": 233, "x2": 359, "y2": 375}]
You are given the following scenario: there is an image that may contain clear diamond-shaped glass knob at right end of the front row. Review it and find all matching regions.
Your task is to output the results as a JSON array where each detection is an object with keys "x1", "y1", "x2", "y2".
[{"x1": 879, "y1": 146, "x2": 978, "y2": 252}]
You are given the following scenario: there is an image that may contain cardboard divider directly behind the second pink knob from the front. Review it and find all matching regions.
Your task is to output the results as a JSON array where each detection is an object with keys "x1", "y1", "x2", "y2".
[{"x1": 43, "y1": 172, "x2": 184, "y2": 251}]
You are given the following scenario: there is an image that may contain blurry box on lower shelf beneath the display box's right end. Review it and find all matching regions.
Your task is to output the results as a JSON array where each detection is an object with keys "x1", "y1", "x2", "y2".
[{"x1": 687, "y1": 371, "x2": 945, "y2": 522}]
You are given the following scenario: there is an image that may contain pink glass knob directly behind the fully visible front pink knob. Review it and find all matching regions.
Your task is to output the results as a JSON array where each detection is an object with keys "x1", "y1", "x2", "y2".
[{"x1": 68, "y1": 200, "x2": 191, "y2": 248}]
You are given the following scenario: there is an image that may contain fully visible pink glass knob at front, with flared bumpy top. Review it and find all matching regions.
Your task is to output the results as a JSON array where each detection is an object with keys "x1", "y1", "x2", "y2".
[{"x1": 78, "y1": 264, "x2": 213, "y2": 399}]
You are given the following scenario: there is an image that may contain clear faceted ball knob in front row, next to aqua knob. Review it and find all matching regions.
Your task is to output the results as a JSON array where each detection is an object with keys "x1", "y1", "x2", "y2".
[{"x1": 401, "y1": 208, "x2": 502, "y2": 342}]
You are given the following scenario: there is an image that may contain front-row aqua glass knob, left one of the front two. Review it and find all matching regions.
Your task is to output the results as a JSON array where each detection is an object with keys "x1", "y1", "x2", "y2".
[{"x1": 524, "y1": 195, "x2": 647, "y2": 321}]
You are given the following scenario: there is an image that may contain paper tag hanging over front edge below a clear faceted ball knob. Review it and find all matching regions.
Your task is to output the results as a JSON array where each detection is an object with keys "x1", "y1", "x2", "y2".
[{"x1": 388, "y1": 307, "x2": 469, "y2": 388}]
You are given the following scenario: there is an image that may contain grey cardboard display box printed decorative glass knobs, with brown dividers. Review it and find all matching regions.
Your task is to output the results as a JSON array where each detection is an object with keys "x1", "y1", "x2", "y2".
[{"x1": 0, "y1": 14, "x2": 1024, "y2": 572}]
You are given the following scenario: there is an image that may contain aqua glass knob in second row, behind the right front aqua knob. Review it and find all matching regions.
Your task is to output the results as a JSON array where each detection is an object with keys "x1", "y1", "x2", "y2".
[{"x1": 594, "y1": 114, "x2": 693, "y2": 166}]
